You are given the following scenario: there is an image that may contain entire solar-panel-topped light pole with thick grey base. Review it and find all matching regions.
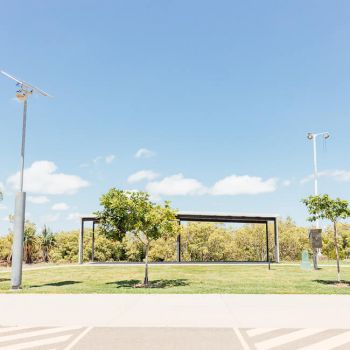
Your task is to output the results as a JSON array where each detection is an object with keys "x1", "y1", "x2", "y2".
[{"x1": 0, "y1": 71, "x2": 50, "y2": 289}]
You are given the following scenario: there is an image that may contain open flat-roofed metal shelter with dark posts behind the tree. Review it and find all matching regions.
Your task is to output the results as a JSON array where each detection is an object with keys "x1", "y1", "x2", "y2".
[{"x1": 79, "y1": 212, "x2": 280, "y2": 264}]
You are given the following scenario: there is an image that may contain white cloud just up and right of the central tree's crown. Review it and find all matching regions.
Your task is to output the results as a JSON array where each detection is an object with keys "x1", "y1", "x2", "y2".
[{"x1": 146, "y1": 174, "x2": 206, "y2": 196}]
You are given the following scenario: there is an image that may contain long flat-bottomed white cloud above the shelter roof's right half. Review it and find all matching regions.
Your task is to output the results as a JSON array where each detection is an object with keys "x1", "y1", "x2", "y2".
[{"x1": 210, "y1": 175, "x2": 277, "y2": 196}]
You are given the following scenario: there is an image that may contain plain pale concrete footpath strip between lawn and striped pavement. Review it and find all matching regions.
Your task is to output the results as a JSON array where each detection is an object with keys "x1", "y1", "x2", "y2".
[{"x1": 0, "y1": 294, "x2": 350, "y2": 328}]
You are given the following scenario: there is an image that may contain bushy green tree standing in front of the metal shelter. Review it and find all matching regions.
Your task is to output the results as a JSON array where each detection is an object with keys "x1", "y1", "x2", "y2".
[{"x1": 97, "y1": 188, "x2": 178, "y2": 286}]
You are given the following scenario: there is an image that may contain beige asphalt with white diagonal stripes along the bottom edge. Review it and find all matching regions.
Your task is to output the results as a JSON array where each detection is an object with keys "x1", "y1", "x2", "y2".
[{"x1": 0, "y1": 327, "x2": 350, "y2": 350}]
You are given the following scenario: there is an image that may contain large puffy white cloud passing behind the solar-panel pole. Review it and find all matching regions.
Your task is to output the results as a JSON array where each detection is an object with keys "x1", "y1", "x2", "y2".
[{"x1": 7, "y1": 160, "x2": 89, "y2": 194}]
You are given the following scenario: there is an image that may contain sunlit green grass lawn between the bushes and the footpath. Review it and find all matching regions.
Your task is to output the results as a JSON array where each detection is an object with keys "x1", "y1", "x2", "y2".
[{"x1": 0, "y1": 265, "x2": 350, "y2": 294}]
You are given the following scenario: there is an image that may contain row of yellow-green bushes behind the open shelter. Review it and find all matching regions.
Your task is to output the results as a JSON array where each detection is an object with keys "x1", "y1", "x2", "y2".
[{"x1": 0, "y1": 218, "x2": 350, "y2": 264}]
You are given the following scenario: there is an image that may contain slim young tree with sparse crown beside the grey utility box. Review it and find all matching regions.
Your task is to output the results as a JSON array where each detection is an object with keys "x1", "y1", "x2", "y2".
[{"x1": 303, "y1": 194, "x2": 350, "y2": 282}]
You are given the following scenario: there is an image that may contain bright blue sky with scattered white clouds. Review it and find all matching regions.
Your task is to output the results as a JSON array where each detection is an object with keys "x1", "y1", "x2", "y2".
[{"x1": 0, "y1": 1, "x2": 350, "y2": 233}]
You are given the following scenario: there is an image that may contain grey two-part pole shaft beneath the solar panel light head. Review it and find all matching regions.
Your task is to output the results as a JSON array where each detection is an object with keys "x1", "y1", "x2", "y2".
[{"x1": 11, "y1": 96, "x2": 28, "y2": 289}]
